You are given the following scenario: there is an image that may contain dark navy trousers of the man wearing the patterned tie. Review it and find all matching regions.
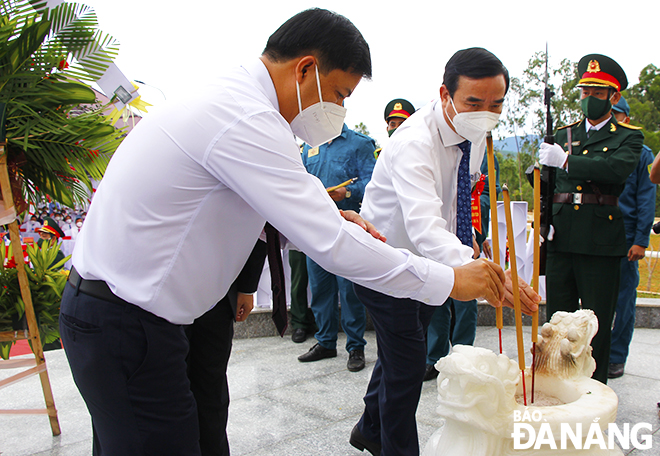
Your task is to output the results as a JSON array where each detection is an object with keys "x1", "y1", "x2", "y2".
[{"x1": 355, "y1": 285, "x2": 434, "y2": 456}]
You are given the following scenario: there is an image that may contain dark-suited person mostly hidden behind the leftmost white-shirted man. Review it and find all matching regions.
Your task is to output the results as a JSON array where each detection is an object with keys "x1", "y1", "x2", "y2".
[{"x1": 186, "y1": 241, "x2": 267, "y2": 456}]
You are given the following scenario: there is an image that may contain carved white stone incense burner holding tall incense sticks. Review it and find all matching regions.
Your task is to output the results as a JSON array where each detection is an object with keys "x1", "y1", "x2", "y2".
[{"x1": 423, "y1": 310, "x2": 623, "y2": 456}]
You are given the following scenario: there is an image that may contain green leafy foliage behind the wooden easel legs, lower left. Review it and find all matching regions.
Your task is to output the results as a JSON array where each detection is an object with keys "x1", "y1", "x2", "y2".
[{"x1": 0, "y1": 242, "x2": 70, "y2": 359}]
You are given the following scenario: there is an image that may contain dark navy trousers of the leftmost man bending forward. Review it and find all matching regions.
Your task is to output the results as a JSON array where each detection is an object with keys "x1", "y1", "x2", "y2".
[{"x1": 60, "y1": 284, "x2": 200, "y2": 456}]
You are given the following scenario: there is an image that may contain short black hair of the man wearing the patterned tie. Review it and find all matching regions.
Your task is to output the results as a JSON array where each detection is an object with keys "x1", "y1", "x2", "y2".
[{"x1": 442, "y1": 48, "x2": 509, "y2": 98}]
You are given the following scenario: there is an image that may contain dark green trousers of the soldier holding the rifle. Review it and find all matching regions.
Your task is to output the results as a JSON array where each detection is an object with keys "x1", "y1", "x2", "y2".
[{"x1": 546, "y1": 252, "x2": 621, "y2": 384}]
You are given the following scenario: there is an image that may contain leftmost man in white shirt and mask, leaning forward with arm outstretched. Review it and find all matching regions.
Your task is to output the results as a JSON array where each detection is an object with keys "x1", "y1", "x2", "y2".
[{"x1": 60, "y1": 9, "x2": 524, "y2": 456}]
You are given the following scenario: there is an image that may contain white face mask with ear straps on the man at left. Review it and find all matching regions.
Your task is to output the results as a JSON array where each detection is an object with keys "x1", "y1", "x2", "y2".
[{"x1": 291, "y1": 65, "x2": 346, "y2": 147}]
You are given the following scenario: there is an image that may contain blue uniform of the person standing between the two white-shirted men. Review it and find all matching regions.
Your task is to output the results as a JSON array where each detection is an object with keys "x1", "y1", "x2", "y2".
[{"x1": 302, "y1": 124, "x2": 376, "y2": 353}]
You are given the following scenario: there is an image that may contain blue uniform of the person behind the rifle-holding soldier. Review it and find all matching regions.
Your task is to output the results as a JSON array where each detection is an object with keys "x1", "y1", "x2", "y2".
[{"x1": 610, "y1": 146, "x2": 655, "y2": 364}]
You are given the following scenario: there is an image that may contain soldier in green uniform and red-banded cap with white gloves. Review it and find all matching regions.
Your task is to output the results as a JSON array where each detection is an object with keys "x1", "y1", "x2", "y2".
[{"x1": 539, "y1": 54, "x2": 644, "y2": 383}]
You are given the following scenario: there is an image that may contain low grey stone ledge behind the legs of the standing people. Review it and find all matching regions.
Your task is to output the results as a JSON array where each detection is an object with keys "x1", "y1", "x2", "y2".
[{"x1": 234, "y1": 298, "x2": 660, "y2": 339}]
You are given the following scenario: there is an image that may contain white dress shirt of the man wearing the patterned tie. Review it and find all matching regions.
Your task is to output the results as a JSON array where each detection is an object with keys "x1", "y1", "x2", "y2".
[{"x1": 360, "y1": 100, "x2": 485, "y2": 304}]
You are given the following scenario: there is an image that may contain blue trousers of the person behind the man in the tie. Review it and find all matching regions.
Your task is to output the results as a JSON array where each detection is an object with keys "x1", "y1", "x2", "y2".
[{"x1": 426, "y1": 298, "x2": 477, "y2": 365}]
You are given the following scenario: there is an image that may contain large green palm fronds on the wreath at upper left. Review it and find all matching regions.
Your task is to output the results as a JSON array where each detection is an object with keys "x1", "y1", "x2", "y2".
[{"x1": 0, "y1": 0, "x2": 124, "y2": 208}]
